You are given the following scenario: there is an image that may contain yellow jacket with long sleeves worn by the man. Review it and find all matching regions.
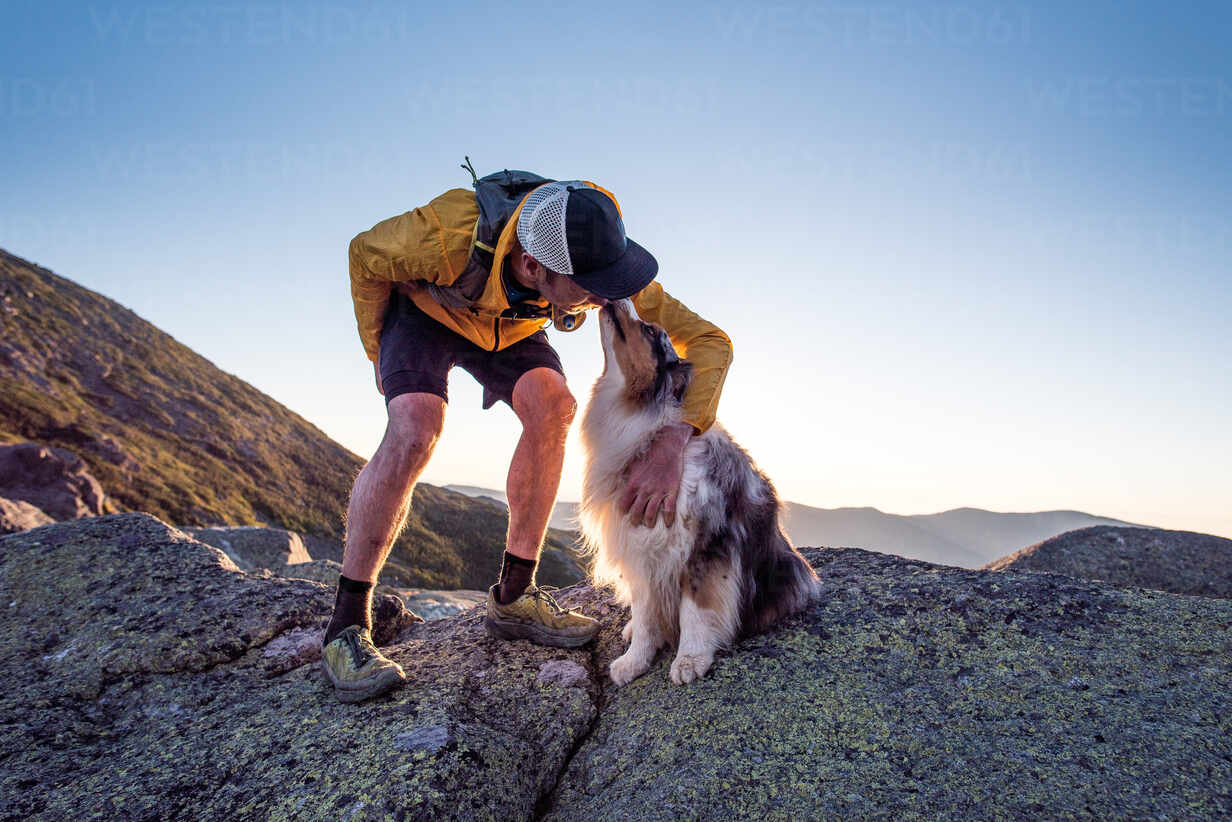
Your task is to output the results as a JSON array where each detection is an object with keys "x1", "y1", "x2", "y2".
[{"x1": 350, "y1": 189, "x2": 732, "y2": 433}]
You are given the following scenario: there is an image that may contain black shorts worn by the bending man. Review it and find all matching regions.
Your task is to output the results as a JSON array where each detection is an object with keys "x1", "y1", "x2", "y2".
[{"x1": 378, "y1": 291, "x2": 564, "y2": 408}]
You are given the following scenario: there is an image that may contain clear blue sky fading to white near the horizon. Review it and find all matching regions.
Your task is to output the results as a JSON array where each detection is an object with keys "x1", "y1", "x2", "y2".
[{"x1": 0, "y1": 0, "x2": 1232, "y2": 537}]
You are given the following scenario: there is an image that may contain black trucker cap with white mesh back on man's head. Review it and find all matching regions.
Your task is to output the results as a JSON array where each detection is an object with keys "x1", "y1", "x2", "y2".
[{"x1": 517, "y1": 180, "x2": 659, "y2": 299}]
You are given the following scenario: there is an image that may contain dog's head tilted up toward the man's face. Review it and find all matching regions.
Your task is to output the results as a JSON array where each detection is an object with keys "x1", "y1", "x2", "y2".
[{"x1": 599, "y1": 299, "x2": 692, "y2": 408}]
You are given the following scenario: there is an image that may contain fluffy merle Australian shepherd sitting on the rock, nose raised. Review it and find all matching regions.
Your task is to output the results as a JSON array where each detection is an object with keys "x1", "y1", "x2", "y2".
[{"x1": 578, "y1": 299, "x2": 819, "y2": 685}]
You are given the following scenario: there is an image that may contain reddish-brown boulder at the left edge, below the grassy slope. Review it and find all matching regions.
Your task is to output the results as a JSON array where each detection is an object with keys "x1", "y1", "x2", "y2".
[{"x1": 0, "y1": 442, "x2": 103, "y2": 520}]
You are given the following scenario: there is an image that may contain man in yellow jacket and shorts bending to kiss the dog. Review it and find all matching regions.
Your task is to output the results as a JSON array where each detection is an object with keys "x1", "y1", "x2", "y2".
[{"x1": 322, "y1": 166, "x2": 732, "y2": 701}]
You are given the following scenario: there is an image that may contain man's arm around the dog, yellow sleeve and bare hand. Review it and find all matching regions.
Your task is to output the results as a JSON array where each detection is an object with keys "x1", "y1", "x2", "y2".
[{"x1": 621, "y1": 282, "x2": 732, "y2": 527}]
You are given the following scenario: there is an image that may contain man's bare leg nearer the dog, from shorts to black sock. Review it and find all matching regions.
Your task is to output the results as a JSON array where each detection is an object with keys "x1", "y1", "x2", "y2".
[{"x1": 505, "y1": 368, "x2": 578, "y2": 569}]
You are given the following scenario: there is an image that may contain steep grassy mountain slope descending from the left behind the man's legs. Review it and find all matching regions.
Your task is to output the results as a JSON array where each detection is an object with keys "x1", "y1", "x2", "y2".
[{"x1": 0, "y1": 249, "x2": 582, "y2": 588}]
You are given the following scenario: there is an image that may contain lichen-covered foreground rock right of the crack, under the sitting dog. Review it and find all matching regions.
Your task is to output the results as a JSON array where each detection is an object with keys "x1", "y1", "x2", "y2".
[{"x1": 541, "y1": 548, "x2": 1232, "y2": 822}]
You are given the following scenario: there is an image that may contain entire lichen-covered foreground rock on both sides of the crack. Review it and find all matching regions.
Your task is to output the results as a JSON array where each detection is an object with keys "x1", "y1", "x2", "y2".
[{"x1": 0, "y1": 514, "x2": 1232, "y2": 822}]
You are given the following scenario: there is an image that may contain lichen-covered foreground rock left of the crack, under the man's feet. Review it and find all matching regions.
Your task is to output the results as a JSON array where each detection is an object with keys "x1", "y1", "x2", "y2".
[{"x1": 0, "y1": 514, "x2": 598, "y2": 822}]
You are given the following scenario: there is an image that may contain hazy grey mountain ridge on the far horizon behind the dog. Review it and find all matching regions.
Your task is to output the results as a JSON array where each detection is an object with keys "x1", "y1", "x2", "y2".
[{"x1": 446, "y1": 484, "x2": 1133, "y2": 568}]
